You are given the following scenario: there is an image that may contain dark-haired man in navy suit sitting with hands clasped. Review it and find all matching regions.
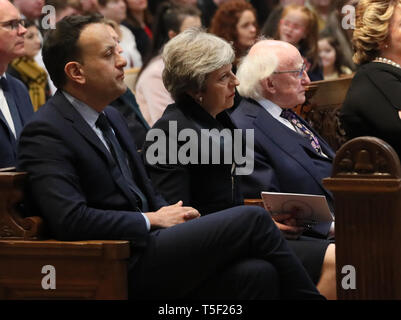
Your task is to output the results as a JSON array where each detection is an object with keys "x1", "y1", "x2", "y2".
[{"x1": 19, "y1": 16, "x2": 321, "y2": 299}]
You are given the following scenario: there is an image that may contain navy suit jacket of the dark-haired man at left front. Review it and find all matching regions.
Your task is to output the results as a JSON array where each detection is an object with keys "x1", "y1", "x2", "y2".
[{"x1": 18, "y1": 92, "x2": 166, "y2": 247}]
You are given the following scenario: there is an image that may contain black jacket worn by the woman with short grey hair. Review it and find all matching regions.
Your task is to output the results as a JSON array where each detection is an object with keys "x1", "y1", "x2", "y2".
[{"x1": 143, "y1": 97, "x2": 243, "y2": 214}]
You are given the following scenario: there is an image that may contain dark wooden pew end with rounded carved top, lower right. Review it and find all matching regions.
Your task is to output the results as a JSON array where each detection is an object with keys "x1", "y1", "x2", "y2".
[{"x1": 323, "y1": 137, "x2": 401, "y2": 300}]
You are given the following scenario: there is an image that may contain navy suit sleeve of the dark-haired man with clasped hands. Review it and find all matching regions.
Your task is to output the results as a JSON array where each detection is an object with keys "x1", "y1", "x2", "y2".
[{"x1": 18, "y1": 121, "x2": 148, "y2": 246}]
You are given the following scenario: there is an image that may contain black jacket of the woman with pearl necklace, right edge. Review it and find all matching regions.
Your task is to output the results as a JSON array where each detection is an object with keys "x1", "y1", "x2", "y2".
[{"x1": 341, "y1": 62, "x2": 401, "y2": 158}]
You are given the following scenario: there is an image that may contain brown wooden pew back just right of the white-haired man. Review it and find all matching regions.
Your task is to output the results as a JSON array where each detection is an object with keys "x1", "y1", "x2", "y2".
[{"x1": 295, "y1": 75, "x2": 353, "y2": 151}]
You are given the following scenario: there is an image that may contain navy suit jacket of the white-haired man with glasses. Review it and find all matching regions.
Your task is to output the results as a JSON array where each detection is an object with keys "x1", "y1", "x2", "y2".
[{"x1": 231, "y1": 99, "x2": 335, "y2": 234}]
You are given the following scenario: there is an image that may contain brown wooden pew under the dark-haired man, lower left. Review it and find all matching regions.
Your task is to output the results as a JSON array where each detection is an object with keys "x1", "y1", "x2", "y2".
[{"x1": 0, "y1": 168, "x2": 130, "y2": 300}]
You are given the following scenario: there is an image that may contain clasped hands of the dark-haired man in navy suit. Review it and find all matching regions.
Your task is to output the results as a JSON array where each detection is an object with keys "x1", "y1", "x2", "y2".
[{"x1": 145, "y1": 201, "x2": 200, "y2": 228}]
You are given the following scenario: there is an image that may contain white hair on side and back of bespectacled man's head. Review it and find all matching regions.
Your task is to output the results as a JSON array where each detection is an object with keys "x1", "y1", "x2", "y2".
[{"x1": 236, "y1": 50, "x2": 278, "y2": 100}]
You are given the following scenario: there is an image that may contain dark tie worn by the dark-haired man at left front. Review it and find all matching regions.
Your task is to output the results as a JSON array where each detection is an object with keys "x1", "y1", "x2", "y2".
[{"x1": 96, "y1": 113, "x2": 149, "y2": 212}]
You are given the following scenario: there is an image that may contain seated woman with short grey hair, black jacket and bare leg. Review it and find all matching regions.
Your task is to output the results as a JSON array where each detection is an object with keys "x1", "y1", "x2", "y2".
[{"x1": 143, "y1": 29, "x2": 335, "y2": 298}]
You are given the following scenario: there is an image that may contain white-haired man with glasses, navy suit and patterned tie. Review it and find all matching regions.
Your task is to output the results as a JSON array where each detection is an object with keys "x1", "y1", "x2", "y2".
[{"x1": 232, "y1": 40, "x2": 335, "y2": 237}]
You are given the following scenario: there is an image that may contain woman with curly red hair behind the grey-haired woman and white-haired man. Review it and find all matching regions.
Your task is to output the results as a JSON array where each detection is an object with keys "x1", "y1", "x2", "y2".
[{"x1": 210, "y1": 0, "x2": 258, "y2": 69}]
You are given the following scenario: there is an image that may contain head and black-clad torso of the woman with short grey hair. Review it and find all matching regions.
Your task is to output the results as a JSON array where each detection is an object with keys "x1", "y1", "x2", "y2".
[{"x1": 144, "y1": 28, "x2": 242, "y2": 214}]
